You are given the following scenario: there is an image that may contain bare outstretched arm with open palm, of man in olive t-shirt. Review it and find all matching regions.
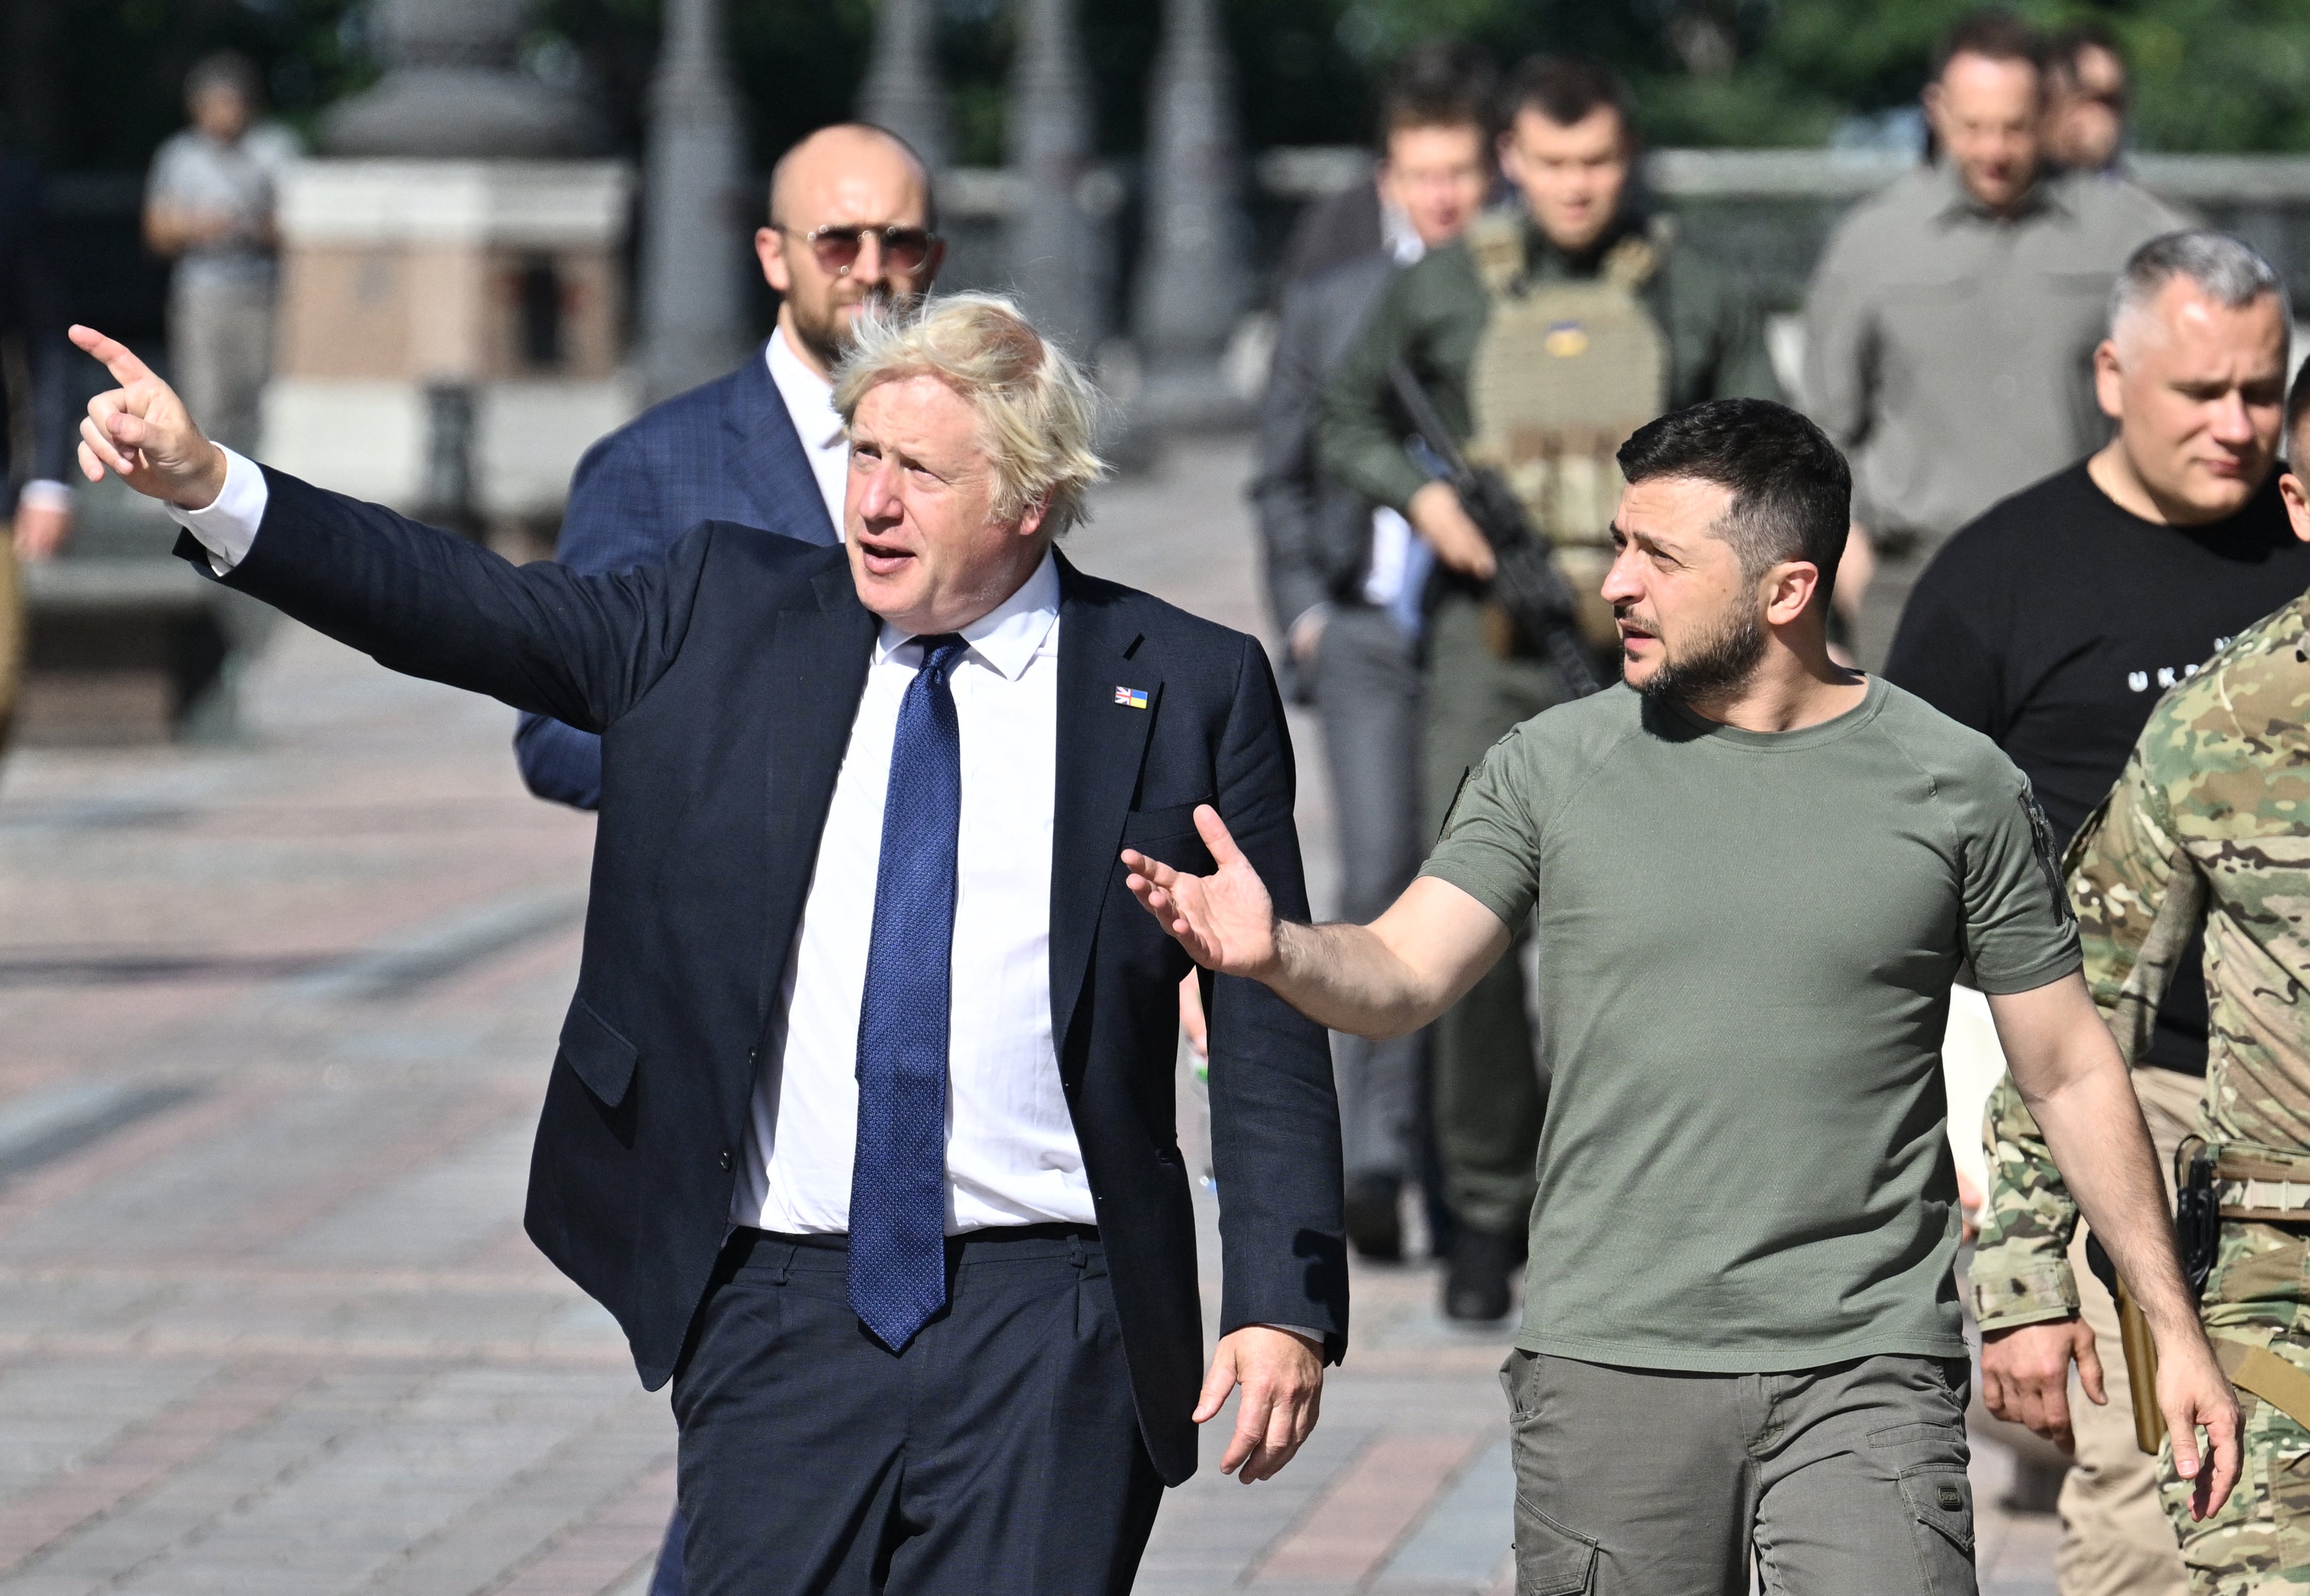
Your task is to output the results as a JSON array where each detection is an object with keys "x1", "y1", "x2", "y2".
[{"x1": 1122, "y1": 804, "x2": 1509, "y2": 1037}]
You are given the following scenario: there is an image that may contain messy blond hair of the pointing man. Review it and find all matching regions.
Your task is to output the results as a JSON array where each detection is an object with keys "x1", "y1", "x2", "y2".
[{"x1": 834, "y1": 293, "x2": 1107, "y2": 536}]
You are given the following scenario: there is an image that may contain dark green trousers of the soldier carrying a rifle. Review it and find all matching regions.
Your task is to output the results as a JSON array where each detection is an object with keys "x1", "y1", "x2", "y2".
[{"x1": 1425, "y1": 594, "x2": 1559, "y2": 1236}]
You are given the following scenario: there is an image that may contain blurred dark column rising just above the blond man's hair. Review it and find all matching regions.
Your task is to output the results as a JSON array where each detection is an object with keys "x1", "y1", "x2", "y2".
[{"x1": 1005, "y1": 0, "x2": 1107, "y2": 358}]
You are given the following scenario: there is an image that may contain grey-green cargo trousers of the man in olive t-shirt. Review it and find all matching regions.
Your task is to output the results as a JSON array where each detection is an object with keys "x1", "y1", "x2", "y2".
[{"x1": 1501, "y1": 1351, "x2": 1975, "y2": 1596}]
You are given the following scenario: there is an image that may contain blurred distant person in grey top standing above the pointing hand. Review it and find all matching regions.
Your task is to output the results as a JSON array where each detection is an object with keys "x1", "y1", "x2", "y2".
[{"x1": 146, "y1": 51, "x2": 298, "y2": 450}]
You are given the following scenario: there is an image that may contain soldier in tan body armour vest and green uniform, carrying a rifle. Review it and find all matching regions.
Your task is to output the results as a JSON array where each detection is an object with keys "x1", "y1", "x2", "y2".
[{"x1": 1321, "y1": 58, "x2": 1779, "y2": 1319}]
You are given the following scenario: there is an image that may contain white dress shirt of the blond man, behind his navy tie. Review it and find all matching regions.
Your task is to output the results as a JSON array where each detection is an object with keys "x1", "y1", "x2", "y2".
[{"x1": 730, "y1": 554, "x2": 1095, "y2": 1236}]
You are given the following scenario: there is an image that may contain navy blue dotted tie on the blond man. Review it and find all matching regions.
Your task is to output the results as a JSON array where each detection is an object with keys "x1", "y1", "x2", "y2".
[{"x1": 850, "y1": 633, "x2": 968, "y2": 1351}]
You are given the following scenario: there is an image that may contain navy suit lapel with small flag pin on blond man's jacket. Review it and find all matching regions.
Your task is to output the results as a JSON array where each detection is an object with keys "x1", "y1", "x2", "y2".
[{"x1": 1051, "y1": 556, "x2": 1162, "y2": 1058}]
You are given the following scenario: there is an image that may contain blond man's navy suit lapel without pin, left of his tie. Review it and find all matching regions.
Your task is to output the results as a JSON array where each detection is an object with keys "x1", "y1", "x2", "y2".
[{"x1": 760, "y1": 566, "x2": 880, "y2": 1019}]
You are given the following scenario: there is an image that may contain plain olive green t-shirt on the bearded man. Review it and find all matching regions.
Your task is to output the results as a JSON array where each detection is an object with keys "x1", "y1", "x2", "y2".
[{"x1": 1423, "y1": 679, "x2": 2079, "y2": 1372}]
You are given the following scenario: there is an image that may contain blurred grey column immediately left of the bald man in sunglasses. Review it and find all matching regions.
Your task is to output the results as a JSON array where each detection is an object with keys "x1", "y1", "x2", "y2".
[{"x1": 640, "y1": 0, "x2": 760, "y2": 400}]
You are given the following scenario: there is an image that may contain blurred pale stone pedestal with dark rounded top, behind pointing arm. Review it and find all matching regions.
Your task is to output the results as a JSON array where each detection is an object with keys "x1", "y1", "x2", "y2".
[{"x1": 263, "y1": 0, "x2": 635, "y2": 529}]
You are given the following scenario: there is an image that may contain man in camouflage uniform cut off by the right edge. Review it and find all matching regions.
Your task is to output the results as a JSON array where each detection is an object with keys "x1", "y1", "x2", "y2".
[{"x1": 1975, "y1": 377, "x2": 2310, "y2": 1596}]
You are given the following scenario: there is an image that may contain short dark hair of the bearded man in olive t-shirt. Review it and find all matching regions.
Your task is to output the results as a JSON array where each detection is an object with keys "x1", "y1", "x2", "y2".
[{"x1": 1619, "y1": 400, "x2": 1853, "y2": 603}]
